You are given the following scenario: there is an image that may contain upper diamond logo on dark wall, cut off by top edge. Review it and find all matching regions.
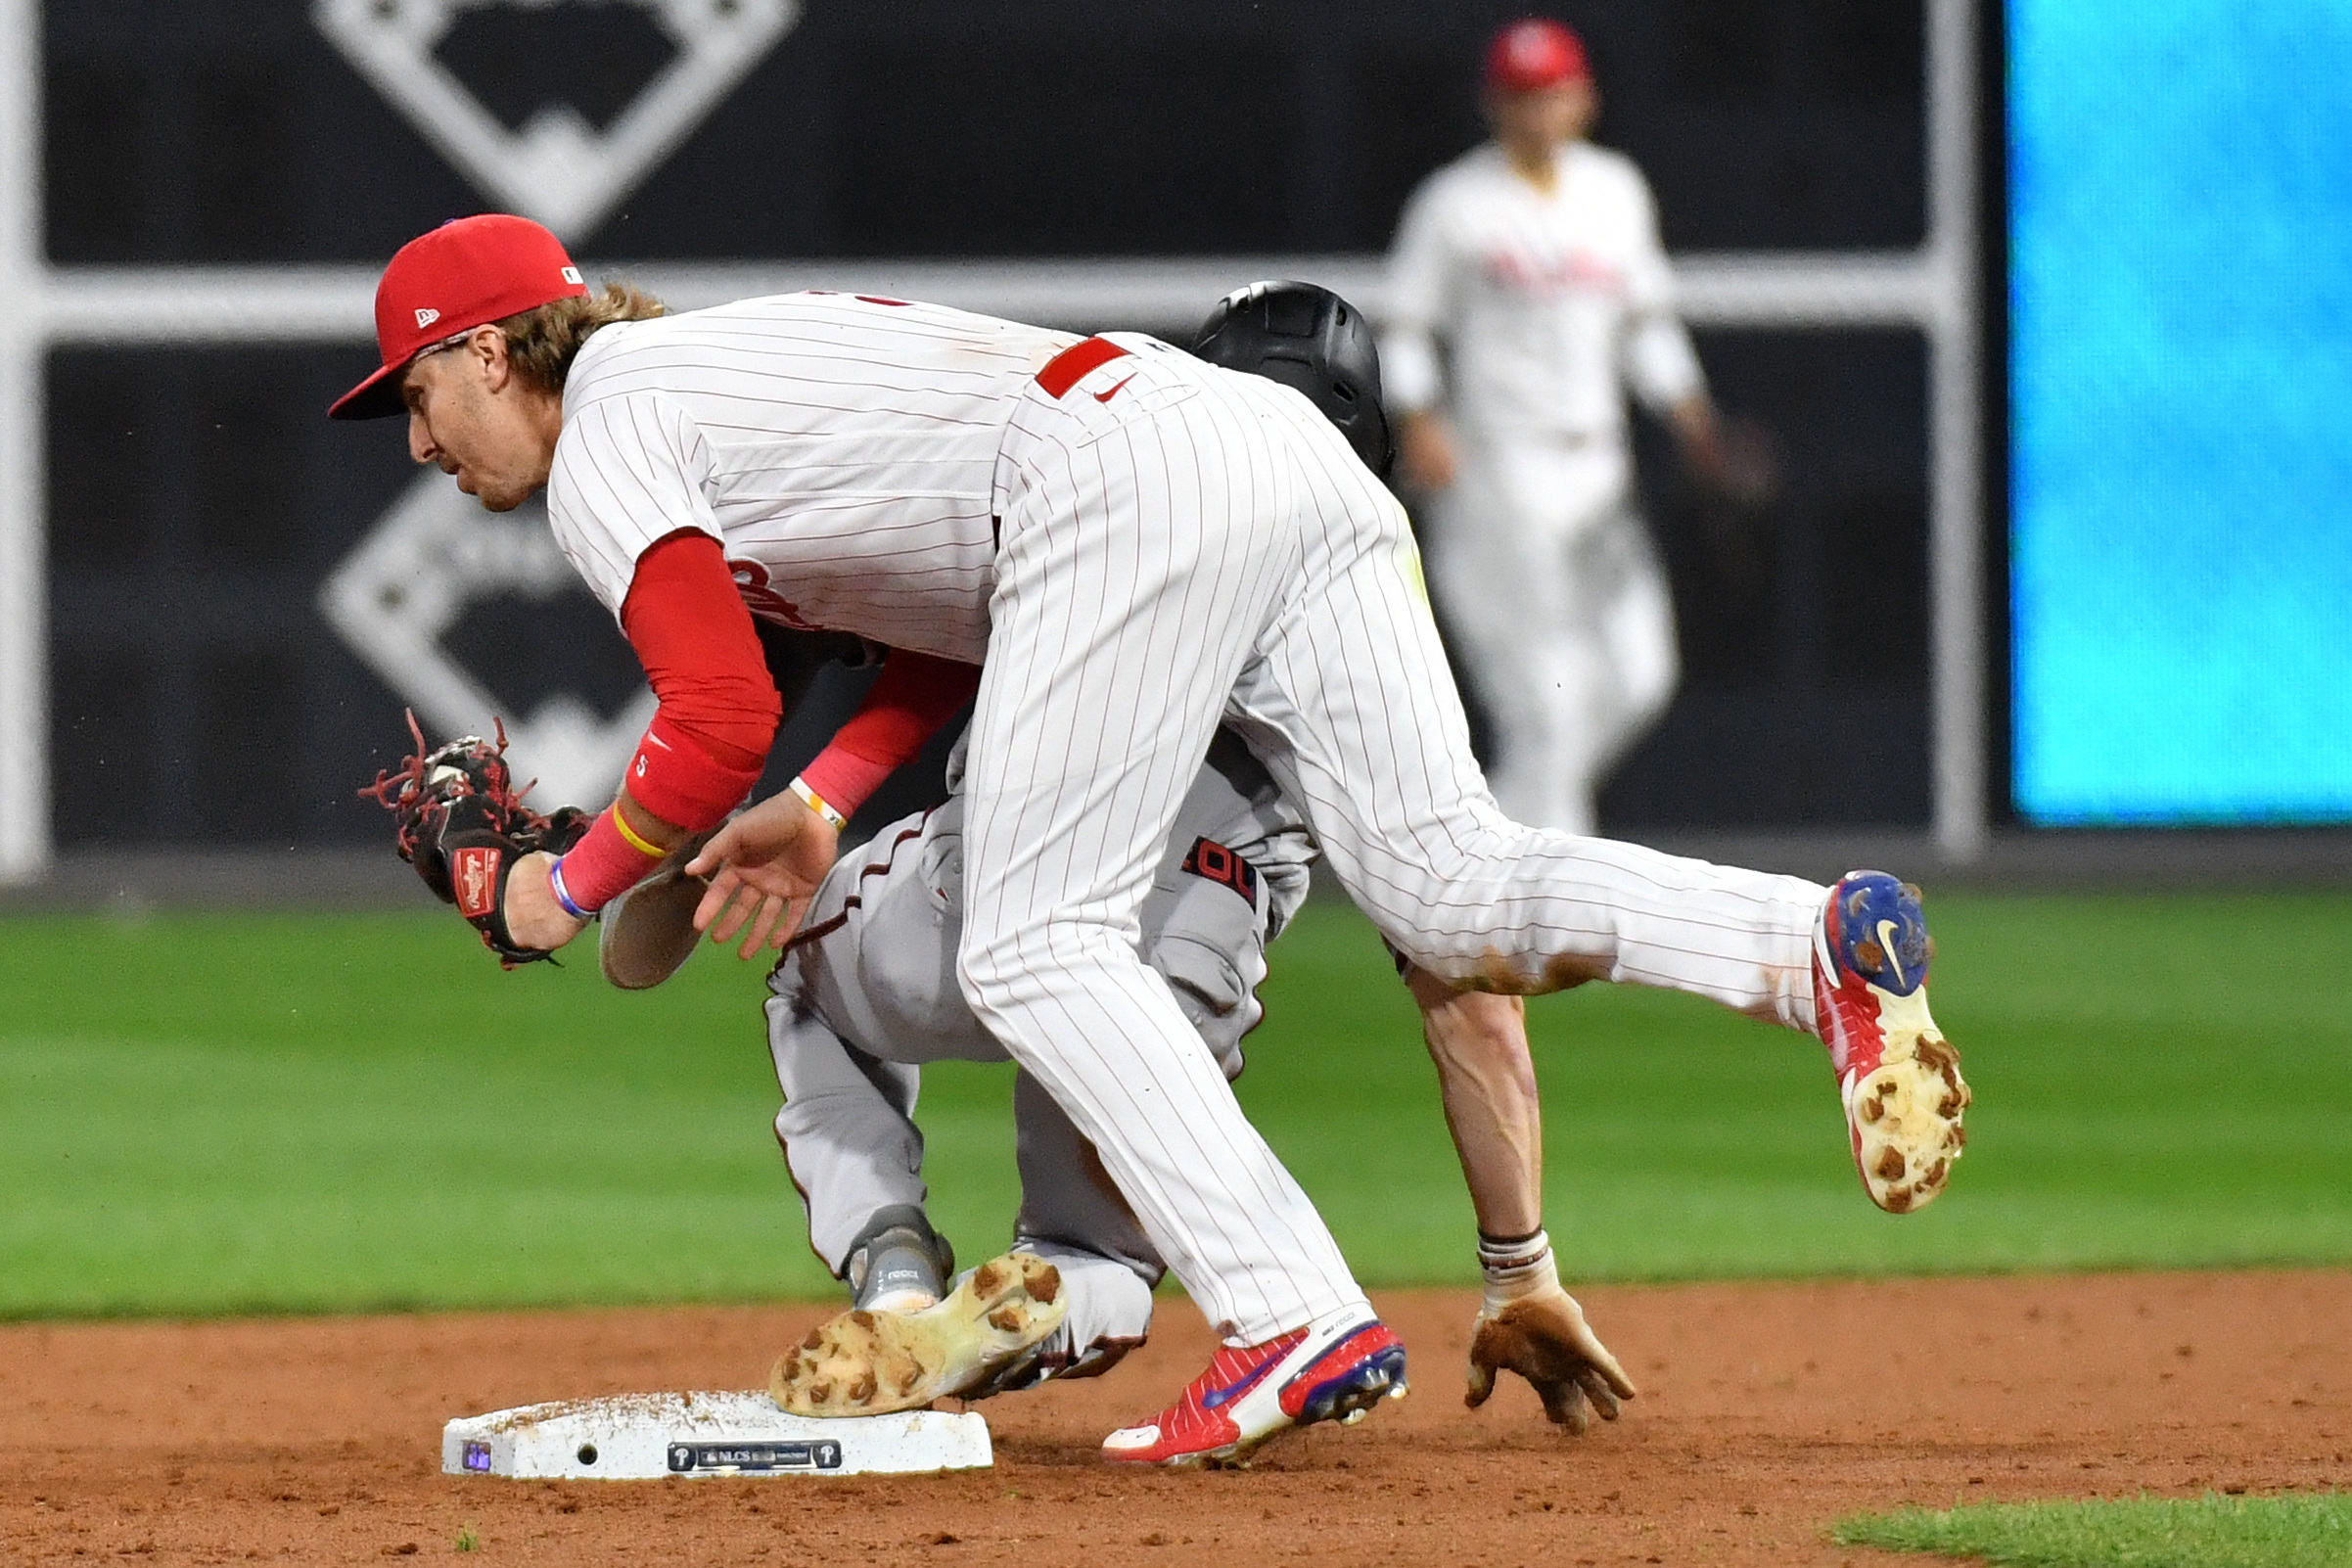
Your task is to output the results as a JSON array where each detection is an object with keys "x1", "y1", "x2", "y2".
[{"x1": 310, "y1": 0, "x2": 800, "y2": 242}]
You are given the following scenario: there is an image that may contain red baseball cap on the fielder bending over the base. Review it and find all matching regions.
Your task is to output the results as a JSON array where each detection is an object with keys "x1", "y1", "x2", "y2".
[{"x1": 327, "y1": 211, "x2": 588, "y2": 419}]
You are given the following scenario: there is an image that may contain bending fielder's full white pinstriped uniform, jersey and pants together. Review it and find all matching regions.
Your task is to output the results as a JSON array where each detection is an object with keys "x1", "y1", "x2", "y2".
[{"x1": 548, "y1": 297, "x2": 1825, "y2": 1345}]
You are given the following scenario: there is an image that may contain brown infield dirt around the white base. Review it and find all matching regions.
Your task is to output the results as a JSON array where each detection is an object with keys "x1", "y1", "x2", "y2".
[{"x1": 0, "y1": 1271, "x2": 2352, "y2": 1568}]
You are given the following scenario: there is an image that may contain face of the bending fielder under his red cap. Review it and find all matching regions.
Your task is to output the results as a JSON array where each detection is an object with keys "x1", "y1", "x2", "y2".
[{"x1": 400, "y1": 332, "x2": 555, "y2": 513}]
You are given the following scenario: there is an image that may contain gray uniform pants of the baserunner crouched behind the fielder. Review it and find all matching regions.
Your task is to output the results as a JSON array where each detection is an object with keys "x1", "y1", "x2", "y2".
[{"x1": 766, "y1": 731, "x2": 1314, "y2": 1380}]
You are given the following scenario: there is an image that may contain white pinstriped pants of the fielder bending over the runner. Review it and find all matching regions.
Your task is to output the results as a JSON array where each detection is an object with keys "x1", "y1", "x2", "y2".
[{"x1": 959, "y1": 334, "x2": 1827, "y2": 1345}]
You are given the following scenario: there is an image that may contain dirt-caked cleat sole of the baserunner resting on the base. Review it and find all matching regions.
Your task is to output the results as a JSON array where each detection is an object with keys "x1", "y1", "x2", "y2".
[{"x1": 766, "y1": 1253, "x2": 1070, "y2": 1415}]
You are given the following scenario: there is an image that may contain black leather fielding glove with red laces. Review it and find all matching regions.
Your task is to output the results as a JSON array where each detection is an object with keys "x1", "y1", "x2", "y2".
[{"x1": 360, "y1": 713, "x2": 590, "y2": 969}]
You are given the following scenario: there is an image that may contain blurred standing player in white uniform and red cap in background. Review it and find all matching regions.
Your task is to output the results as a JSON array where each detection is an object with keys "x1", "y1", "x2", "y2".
[{"x1": 1381, "y1": 19, "x2": 1771, "y2": 832}]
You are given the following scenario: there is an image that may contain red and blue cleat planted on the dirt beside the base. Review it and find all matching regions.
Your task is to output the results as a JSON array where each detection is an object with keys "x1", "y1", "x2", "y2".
[{"x1": 1103, "y1": 1318, "x2": 1405, "y2": 1469}]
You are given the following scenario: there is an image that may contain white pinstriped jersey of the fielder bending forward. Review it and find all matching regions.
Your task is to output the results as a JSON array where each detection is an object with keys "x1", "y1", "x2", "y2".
[{"x1": 548, "y1": 294, "x2": 1075, "y2": 663}]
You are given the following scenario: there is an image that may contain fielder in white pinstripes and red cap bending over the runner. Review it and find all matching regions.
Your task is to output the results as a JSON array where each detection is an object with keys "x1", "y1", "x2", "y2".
[{"x1": 334, "y1": 216, "x2": 1966, "y2": 1464}]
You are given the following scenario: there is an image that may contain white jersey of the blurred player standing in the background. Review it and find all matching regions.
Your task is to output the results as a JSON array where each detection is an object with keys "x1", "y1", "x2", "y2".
[{"x1": 1381, "y1": 141, "x2": 1705, "y2": 442}]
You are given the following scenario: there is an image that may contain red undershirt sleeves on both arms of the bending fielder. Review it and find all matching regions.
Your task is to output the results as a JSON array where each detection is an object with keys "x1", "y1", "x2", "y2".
[{"x1": 562, "y1": 529, "x2": 981, "y2": 909}]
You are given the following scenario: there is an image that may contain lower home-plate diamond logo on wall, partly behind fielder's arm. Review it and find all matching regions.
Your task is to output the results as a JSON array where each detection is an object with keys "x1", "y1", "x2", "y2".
[{"x1": 317, "y1": 470, "x2": 654, "y2": 808}]
